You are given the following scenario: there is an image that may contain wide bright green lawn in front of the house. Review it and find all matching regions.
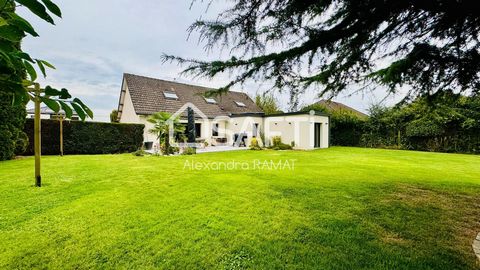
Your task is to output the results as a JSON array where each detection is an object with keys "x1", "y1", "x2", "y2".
[{"x1": 0, "y1": 148, "x2": 480, "y2": 269}]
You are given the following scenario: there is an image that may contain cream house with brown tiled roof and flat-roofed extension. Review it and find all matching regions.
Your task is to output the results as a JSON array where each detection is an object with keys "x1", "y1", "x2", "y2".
[{"x1": 118, "y1": 74, "x2": 330, "y2": 149}]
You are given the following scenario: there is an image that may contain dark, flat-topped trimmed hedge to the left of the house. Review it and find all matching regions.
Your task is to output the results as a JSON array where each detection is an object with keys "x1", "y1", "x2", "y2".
[{"x1": 25, "y1": 119, "x2": 145, "y2": 155}]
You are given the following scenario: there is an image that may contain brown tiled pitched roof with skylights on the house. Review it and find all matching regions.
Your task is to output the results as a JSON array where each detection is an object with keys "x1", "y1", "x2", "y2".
[{"x1": 120, "y1": 74, "x2": 262, "y2": 117}]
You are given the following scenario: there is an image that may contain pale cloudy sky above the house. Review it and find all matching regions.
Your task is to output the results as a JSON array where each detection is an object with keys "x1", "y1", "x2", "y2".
[{"x1": 19, "y1": 0, "x2": 398, "y2": 121}]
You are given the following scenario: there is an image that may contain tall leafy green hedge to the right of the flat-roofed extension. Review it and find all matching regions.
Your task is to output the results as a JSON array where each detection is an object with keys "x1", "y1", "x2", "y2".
[{"x1": 361, "y1": 90, "x2": 480, "y2": 154}]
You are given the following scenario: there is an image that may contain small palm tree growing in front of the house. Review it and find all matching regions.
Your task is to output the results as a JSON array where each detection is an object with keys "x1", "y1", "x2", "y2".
[{"x1": 147, "y1": 112, "x2": 185, "y2": 155}]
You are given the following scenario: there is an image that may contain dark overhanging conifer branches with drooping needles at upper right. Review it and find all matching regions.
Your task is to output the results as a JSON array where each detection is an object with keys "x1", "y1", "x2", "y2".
[{"x1": 163, "y1": 0, "x2": 480, "y2": 102}]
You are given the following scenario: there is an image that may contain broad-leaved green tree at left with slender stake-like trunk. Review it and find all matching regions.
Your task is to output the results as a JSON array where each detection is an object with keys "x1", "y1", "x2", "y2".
[{"x1": 0, "y1": 0, "x2": 93, "y2": 187}]
